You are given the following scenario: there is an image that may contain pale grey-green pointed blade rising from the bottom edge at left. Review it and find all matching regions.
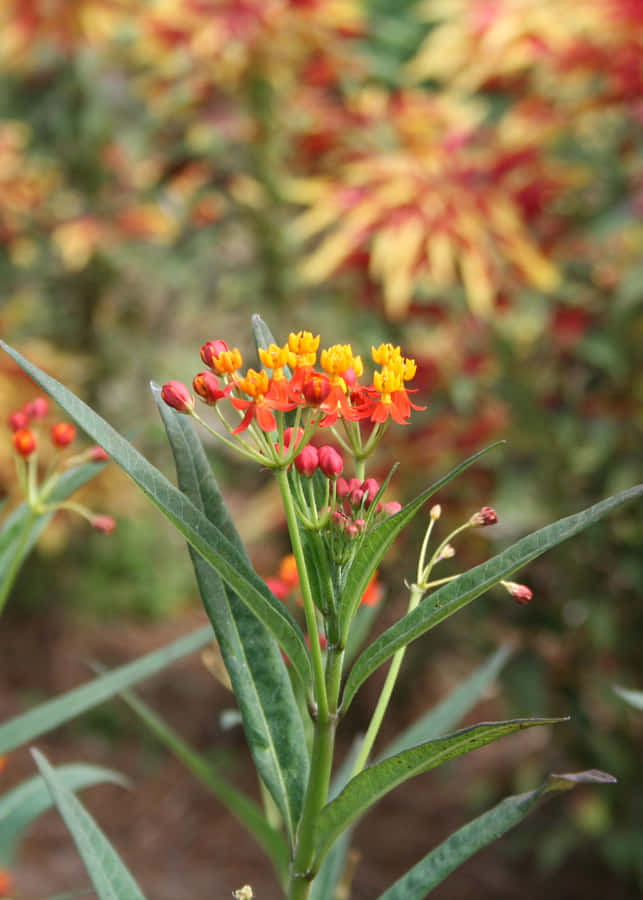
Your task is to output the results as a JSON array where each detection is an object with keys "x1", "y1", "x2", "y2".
[{"x1": 31, "y1": 749, "x2": 145, "y2": 900}]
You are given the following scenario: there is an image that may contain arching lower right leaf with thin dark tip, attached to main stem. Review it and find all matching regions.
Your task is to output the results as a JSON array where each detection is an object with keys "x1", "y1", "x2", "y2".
[{"x1": 313, "y1": 718, "x2": 567, "y2": 871}]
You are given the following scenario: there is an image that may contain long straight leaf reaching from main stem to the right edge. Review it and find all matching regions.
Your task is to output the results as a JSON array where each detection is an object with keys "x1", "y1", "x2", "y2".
[{"x1": 342, "y1": 485, "x2": 643, "y2": 713}]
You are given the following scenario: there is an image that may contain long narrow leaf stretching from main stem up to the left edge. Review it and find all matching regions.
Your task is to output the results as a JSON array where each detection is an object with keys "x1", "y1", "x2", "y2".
[{"x1": 0, "y1": 341, "x2": 312, "y2": 685}]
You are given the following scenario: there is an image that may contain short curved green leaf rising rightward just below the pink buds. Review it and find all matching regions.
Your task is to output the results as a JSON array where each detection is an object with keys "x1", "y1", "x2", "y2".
[{"x1": 338, "y1": 441, "x2": 504, "y2": 632}]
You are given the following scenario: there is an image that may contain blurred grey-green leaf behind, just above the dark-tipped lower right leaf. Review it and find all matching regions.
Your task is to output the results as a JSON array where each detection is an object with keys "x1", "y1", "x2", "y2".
[{"x1": 380, "y1": 644, "x2": 512, "y2": 758}]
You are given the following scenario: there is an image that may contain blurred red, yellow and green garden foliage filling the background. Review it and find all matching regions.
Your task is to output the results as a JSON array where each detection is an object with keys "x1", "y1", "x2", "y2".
[{"x1": 0, "y1": 0, "x2": 643, "y2": 884}]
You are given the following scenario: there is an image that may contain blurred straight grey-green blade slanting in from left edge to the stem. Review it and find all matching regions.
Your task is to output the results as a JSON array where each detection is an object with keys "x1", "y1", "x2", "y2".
[{"x1": 0, "y1": 625, "x2": 212, "y2": 753}]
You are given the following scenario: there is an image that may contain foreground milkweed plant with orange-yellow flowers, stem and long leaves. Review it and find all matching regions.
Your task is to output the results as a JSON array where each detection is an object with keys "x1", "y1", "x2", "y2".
[{"x1": 0, "y1": 316, "x2": 642, "y2": 900}]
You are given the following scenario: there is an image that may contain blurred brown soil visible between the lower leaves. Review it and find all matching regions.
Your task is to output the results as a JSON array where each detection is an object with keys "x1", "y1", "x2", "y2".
[{"x1": 0, "y1": 613, "x2": 639, "y2": 900}]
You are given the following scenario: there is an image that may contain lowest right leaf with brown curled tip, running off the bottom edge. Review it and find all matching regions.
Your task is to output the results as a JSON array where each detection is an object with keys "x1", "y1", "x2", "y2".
[{"x1": 378, "y1": 770, "x2": 616, "y2": 900}]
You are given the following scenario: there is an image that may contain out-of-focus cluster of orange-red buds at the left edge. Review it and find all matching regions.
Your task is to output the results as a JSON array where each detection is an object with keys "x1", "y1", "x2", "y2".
[{"x1": 8, "y1": 397, "x2": 116, "y2": 534}]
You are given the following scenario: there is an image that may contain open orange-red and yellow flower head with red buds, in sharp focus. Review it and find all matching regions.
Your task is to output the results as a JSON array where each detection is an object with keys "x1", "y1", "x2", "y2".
[{"x1": 161, "y1": 331, "x2": 424, "y2": 477}]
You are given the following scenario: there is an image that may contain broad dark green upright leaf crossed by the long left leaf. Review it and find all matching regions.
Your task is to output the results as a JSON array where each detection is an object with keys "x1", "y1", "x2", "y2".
[{"x1": 155, "y1": 391, "x2": 309, "y2": 841}]
